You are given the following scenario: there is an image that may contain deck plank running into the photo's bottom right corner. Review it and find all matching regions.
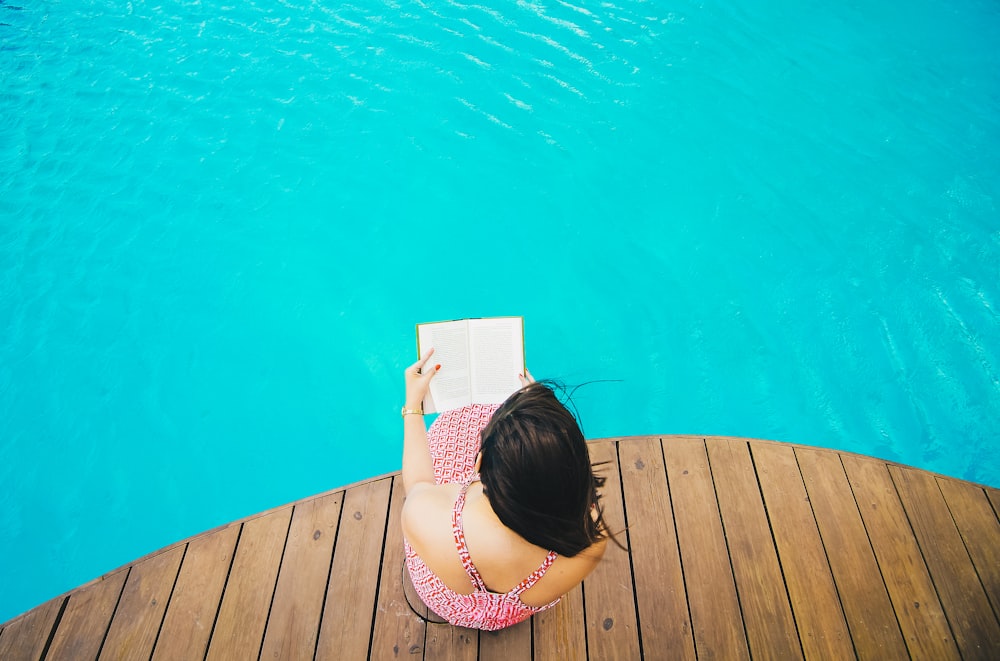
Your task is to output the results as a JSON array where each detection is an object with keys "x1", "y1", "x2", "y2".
[{"x1": 889, "y1": 466, "x2": 1000, "y2": 659}]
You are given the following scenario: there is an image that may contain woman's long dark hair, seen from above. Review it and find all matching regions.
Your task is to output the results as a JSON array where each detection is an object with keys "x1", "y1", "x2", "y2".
[{"x1": 479, "y1": 382, "x2": 608, "y2": 556}]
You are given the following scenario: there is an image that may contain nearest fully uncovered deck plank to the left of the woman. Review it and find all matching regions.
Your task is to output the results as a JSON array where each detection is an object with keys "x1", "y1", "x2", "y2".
[{"x1": 316, "y1": 478, "x2": 393, "y2": 659}]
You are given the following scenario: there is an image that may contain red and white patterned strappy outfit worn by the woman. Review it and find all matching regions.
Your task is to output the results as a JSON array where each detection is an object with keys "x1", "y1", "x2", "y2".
[{"x1": 405, "y1": 404, "x2": 559, "y2": 631}]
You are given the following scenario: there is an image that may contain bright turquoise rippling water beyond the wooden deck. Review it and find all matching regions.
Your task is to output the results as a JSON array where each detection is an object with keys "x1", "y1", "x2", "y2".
[{"x1": 0, "y1": 0, "x2": 1000, "y2": 621}]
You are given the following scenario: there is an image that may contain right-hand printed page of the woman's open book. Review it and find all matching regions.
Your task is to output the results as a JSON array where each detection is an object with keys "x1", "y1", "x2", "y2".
[{"x1": 469, "y1": 317, "x2": 524, "y2": 404}]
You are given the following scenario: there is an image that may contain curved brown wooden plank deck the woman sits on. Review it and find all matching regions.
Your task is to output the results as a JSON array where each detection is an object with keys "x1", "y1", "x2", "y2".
[{"x1": 0, "y1": 436, "x2": 1000, "y2": 661}]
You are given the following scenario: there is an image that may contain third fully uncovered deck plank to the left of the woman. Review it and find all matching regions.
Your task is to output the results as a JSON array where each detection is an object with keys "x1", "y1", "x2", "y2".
[{"x1": 207, "y1": 507, "x2": 292, "y2": 661}]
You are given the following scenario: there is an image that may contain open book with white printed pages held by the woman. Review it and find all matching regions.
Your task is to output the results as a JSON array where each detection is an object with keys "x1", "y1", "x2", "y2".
[{"x1": 417, "y1": 317, "x2": 524, "y2": 413}]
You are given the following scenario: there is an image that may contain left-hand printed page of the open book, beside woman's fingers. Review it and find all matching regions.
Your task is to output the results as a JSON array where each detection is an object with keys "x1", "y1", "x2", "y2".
[{"x1": 417, "y1": 320, "x2": 472, "y2": 413}]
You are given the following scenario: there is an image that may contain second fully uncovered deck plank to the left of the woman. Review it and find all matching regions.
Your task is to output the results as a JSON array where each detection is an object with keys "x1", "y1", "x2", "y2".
[{"x1": 260, "y1": 491, "x2": 344, "y2": 659}]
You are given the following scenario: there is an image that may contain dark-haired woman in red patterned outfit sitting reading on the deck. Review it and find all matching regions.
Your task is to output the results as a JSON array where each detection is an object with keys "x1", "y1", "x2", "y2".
[{"x1": 402, "y1": 349, "x2": 608, "y2": 630}]
